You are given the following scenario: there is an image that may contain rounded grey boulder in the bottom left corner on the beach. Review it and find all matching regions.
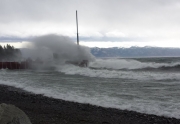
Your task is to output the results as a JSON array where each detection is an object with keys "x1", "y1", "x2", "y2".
[{"x1": 0, "y1": 103, "x2": 31, "y2": 124}]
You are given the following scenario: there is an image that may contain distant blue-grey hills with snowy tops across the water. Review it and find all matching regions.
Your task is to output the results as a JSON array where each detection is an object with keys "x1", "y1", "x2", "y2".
[{"x1": 91, "y1": 47, "x2": 180, "y2": 57}]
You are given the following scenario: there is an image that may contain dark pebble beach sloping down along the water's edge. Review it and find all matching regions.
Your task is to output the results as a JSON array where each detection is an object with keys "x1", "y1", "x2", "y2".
[{"x1": 0, "y1": 85, "x2": 180, "y2": 124}]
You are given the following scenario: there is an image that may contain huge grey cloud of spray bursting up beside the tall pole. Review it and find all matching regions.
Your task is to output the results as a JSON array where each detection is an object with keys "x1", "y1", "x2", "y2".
[{"x1": 23, "y1": 34, "x2": 95, "y2": 63}]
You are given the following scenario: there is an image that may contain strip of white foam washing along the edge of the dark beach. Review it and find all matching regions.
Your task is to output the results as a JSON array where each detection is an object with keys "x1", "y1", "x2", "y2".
[{"x1": 0, "y1": 77, "x2": 180, "y2": 119}]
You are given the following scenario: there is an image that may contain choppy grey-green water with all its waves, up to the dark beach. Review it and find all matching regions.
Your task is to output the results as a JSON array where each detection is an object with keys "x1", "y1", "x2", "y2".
[{"x1": 0, "y1": 58, "x2": 180, "y2": 118}]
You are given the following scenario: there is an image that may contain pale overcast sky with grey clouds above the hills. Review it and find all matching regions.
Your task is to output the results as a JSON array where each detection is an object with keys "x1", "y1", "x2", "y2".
[{"x1": 0, "y1": 0, "x2": 180, "y2": 48}]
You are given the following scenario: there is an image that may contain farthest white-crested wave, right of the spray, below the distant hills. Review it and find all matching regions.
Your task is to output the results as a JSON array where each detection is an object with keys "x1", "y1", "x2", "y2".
[{"x1": 89, "y1": 59, "x2": 180, "y2": 71}]
